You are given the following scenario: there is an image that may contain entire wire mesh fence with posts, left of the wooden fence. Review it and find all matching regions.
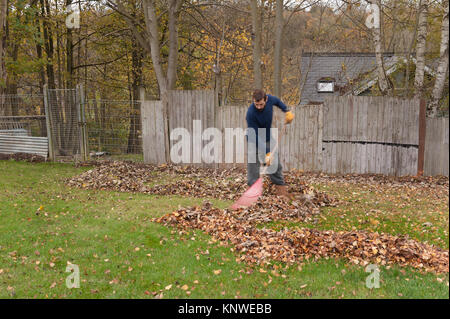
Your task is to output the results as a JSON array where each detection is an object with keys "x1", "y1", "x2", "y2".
[{"x1": 0, "y1": 86, "x2": 143, "y2": 161}]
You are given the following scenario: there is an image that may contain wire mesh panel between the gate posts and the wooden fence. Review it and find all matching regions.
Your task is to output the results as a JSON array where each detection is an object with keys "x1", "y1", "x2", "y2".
[{"x1": 85, "y1": 99, "x2": 142, "y2": 156}]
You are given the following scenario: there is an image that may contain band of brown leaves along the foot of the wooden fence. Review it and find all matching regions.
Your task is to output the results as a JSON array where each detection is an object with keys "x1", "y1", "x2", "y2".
[{"x1": 68, "y1": 161, "x2": 449, "y2": 200}]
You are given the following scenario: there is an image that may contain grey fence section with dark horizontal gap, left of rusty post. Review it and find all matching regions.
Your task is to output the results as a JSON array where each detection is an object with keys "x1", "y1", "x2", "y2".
[{"x1": 322, "y1": 96, "x2": 419, "y2": 175}]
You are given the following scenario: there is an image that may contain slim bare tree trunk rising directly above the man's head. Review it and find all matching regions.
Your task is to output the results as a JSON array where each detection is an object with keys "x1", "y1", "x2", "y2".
[{"x1": 250, "y1": 0, "x2": 263, "y2": 89}]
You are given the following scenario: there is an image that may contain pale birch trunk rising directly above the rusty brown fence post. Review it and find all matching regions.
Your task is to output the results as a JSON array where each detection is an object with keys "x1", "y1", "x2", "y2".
[{"x1": 414, "y1": 0, "x2": 428, "y2": 98}]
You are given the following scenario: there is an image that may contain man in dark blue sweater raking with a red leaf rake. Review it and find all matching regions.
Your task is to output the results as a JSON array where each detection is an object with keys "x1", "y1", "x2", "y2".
[{"x1": 231, "y1": 90, "x2": 294, "y2": 209}]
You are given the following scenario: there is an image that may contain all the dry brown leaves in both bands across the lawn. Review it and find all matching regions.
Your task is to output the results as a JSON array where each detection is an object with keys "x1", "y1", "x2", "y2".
[{"x1": 68, "y1": 162, "x2": 449, "y2": 273}]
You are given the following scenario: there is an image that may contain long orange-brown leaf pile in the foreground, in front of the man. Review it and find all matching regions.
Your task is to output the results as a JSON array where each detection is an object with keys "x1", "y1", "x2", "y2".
[{"x1": 154, "y1": 202, "x2": 449, "y2": 273}]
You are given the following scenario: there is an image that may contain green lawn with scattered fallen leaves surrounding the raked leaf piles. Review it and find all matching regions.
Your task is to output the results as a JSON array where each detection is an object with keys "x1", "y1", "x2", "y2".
[{"x1": 0, "y1": 161, "x2": 449, "y2": 298}]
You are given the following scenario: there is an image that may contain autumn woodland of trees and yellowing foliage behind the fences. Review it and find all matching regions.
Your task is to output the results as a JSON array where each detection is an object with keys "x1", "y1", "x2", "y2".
[{"x1": 0, "y1": 0, "x2": 448, "y2": 115}]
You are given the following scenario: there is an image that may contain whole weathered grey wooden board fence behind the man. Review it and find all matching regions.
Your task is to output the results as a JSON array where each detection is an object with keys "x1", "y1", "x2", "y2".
[{"x1": 141, "y1": 91, "x2": 448, "y2": 176}]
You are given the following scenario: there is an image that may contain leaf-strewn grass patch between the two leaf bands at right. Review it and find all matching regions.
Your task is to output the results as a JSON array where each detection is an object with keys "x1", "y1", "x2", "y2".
[{"x1": 261, "y1": 183, "x2": 449, "y2": 249}]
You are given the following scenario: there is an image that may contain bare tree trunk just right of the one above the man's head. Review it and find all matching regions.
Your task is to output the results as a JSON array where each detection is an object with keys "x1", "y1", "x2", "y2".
[{"x1": 273, "y1": 0, "x2": 284, "y2": 98}]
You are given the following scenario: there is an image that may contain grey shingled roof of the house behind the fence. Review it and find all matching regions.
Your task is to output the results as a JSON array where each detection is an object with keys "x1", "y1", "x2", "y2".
[{"x1": 300, "y1": 52, "x2": 398, "y2": 104}]
